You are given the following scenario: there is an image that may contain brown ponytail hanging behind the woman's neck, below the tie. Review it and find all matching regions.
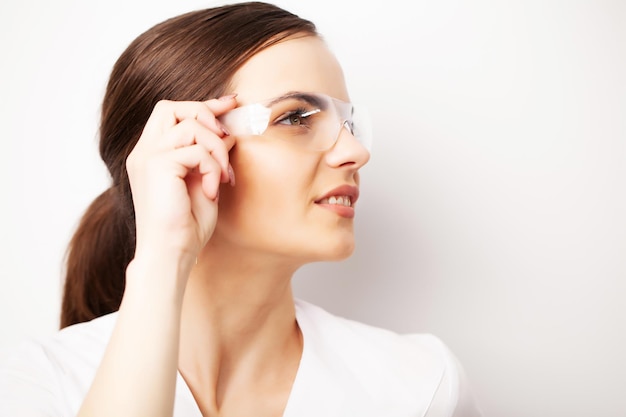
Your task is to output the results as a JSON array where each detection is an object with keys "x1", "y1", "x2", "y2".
[{"x1": 61, "y1": 187, "x2": 134, "y2": 328}]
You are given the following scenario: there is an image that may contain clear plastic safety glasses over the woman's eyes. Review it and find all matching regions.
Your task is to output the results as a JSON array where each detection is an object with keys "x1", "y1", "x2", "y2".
[{"x1": 219, "y1": 92, "x2": 372, "y2": 151}]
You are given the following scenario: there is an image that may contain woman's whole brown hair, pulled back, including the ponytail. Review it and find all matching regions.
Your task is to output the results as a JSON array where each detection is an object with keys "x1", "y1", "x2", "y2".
[{"x1": 61, "y1": 2, "x2": 318, "y2": 328}]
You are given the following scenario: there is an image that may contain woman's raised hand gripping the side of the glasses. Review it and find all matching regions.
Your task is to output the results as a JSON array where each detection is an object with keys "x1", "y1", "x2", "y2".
[{"x1": 126, "y1": 96, "x2": 236, "y2": 268}]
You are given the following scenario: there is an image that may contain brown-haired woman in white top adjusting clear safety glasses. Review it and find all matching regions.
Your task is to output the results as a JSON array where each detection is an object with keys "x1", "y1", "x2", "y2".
[{"x1": 0, "y1": 3, "x2": 478, "y2": 417}]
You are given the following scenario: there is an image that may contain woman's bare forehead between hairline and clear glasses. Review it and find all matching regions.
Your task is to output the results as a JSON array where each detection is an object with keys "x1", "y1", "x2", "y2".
[{"x1": 232, "y1": 36, "x2": 349, "y2": 104}]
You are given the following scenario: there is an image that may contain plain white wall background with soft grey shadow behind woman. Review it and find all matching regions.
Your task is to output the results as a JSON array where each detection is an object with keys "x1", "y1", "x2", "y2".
[{"x1": 0, "y1": 0, "x2": 626, "y2": 417}]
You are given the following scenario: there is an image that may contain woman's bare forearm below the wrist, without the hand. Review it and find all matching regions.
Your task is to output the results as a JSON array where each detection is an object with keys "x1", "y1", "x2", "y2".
[{"x1": 78, "y1": 257, "x2": 189, "y2": 417}]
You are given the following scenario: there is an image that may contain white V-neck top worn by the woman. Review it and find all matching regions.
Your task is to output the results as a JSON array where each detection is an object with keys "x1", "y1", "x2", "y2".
[{"x1": 0, "y1": 300, "x2": 481, "y2": 417}]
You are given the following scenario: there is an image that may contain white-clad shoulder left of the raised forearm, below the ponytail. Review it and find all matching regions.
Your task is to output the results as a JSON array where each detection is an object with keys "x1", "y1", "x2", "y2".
[{"x1": 0, "y1": 313, "x2": 117, "y2": 416}]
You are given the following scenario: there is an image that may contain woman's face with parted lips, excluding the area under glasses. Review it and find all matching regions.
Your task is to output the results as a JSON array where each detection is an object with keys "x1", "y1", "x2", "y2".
[{"x1": 212, "y1": 36, "x2": 369, "y2": 263}]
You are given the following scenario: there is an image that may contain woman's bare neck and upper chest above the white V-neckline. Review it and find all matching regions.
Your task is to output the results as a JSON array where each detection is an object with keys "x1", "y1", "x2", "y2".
[{"x1": 179, "y1": 244, "x2": 302, "y2": 408}]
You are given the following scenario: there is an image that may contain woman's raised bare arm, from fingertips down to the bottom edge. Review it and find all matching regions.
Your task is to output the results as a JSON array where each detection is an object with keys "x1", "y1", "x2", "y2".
[{"x1": 78, "y1": 97, "x2": 235, "y2": 417}]
